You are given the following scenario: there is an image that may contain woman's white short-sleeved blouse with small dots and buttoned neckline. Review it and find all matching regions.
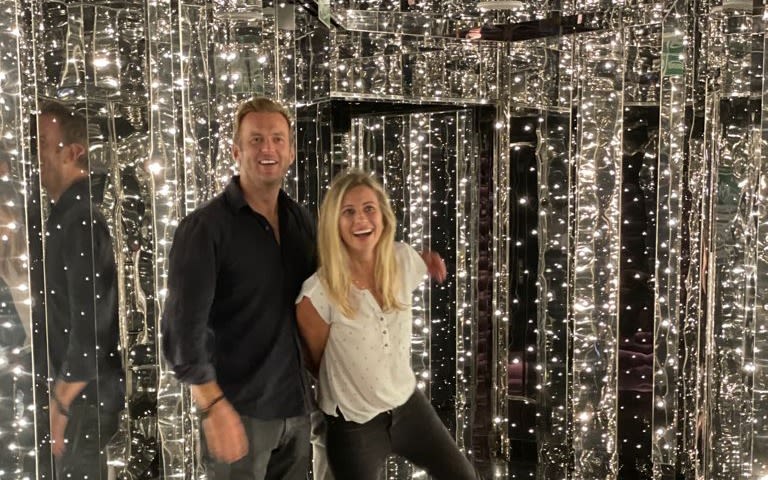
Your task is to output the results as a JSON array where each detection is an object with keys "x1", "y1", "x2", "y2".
[{"x1": 296, "y1": 242, "x2": 427, "y2": 423}]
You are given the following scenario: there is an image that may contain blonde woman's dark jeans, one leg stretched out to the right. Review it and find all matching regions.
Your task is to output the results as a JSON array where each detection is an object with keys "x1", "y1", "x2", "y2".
[{"x1": 326, "y1": 390, "x2": 478, "y2": 480}]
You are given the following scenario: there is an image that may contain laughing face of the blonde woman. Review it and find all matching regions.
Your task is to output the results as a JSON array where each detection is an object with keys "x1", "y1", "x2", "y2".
[{"x1": 339, "y1": 185, "x2": 384, "y2": 256}]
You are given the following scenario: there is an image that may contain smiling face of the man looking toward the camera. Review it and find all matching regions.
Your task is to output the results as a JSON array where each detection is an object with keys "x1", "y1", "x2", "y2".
[{"x1": 232, "y1": 112, "x2": 294, "y2": 190}]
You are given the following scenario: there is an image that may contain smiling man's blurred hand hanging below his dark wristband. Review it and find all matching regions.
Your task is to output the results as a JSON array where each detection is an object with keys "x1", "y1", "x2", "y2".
[{"x1": 202, "y1": 399, "x2": 248, "y2": 463}]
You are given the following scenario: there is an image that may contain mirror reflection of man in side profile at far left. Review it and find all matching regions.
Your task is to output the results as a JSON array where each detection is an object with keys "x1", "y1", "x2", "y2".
[{"x1": 38, "y1": 102, "x2": 125, "y2": 479}]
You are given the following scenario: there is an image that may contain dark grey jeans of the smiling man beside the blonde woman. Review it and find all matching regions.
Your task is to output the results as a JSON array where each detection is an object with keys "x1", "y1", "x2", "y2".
[{"x1": 202, "y1": 415, "x2": 310, "y2": 480}]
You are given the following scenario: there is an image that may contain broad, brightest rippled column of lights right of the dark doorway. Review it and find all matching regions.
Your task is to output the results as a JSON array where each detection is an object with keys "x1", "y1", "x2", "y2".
[{"x1": 572, "y1": 29, "x2": 624, "y2": 479}]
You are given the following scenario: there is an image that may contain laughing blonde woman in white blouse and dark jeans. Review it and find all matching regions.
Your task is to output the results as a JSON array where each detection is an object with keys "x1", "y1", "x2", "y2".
[{"x1": 297, "y1": 172, "x2": 477, "y2": 480}]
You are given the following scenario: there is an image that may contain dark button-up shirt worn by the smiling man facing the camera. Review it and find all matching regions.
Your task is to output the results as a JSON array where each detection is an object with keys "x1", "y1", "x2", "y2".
[{"x1": 162, "y1": 176, "x2": 316, "y2": 420}]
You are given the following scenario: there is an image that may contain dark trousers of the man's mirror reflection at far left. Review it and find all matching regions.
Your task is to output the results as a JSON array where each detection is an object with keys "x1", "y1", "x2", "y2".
[{"x1": 56, "y1": 405, "x2": 120, "y2": 480}]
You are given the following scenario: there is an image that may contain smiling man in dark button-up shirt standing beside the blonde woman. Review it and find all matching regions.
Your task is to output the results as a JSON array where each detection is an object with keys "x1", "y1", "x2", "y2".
[{"x1": 162, "y1": 98, "x2": 316, "y2": 480}]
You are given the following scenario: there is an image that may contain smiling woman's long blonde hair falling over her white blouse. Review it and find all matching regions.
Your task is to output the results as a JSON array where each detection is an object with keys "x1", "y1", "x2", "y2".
[{"x1": 317, "y1": 170, "x2": 403, "y2": 318}]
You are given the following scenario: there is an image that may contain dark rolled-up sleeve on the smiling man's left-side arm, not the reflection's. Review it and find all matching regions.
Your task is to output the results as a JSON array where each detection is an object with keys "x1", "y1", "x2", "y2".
[{"x1": 161, "y1": 217, "x2": 217, "y2": 385}]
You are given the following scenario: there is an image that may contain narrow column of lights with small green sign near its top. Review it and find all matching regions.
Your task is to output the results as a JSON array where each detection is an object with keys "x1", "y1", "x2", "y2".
[{"x1": 651, "y1": 6, "x2": 689, "y2": 480}]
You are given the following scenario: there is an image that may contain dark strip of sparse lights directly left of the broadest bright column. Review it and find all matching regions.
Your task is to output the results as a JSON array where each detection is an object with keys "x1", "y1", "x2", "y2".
[{"x1": 536, "y1": 36, "x2": 574, "y2": 479}]
